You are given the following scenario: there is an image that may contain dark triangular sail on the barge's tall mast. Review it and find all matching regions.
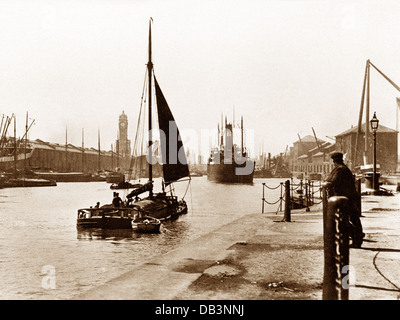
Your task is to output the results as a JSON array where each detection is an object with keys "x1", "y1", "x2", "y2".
[{"x1": 154, "y1": 77, "x2": 189, "y2": 185}]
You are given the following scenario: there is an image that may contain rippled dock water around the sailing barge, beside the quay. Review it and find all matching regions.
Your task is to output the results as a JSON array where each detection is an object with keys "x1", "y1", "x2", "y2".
[{"x1": 0, "y1": 177, "x2": 279, "y2": 299}]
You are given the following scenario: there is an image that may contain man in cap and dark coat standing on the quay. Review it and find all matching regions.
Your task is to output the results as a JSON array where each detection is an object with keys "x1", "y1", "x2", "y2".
[{"x1": 326, "y1": 152, "x2": 365, "y2": 248}]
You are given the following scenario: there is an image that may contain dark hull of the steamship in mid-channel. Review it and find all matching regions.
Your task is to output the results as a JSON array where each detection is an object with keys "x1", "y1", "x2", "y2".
[{"x1": 207, "y1": 160, "x2": 254, "y2": 184}]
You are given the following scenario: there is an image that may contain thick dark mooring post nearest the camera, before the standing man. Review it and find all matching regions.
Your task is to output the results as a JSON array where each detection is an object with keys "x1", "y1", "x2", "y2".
[{"x1": 322, "y1": 196, "x2": 349, "y2": 300}]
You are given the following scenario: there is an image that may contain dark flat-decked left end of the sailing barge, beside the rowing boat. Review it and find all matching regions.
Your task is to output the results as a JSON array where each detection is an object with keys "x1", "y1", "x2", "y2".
[{"x1": 76, "y1": 205, "x2": 137, "y2": 229}]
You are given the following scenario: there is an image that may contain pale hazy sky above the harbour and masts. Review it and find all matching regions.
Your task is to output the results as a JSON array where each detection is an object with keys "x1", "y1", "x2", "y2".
[{"x1": 0, "y1": 0, "x2": 400, "y2": 160}]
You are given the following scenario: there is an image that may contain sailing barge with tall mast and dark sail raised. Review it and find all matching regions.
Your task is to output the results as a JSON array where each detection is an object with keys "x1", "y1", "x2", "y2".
[{"x1": 78, "y1": 20, "x2": 190, "y2": 228}]
